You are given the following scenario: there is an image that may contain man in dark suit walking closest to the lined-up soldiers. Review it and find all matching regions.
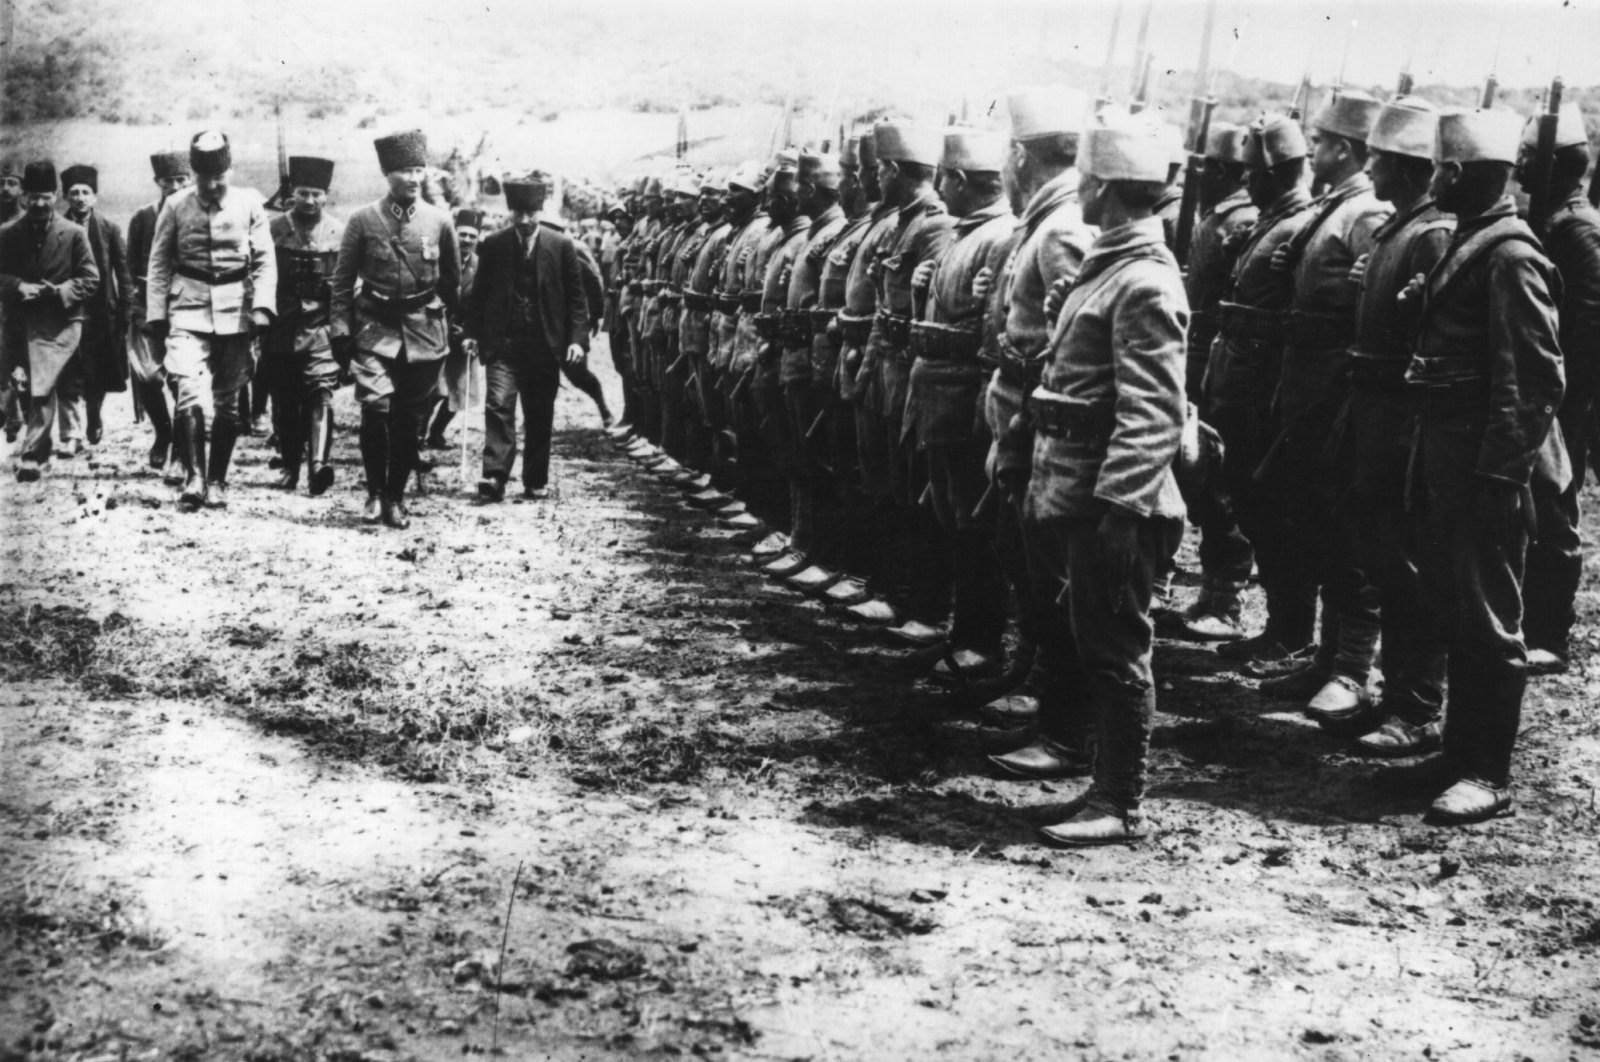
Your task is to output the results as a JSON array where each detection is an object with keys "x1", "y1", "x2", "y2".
[{"x1": 466, "y1": 171, "x2": 589, "y2": 501}]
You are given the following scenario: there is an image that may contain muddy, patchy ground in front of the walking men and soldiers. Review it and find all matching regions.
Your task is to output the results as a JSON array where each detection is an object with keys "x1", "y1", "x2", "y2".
[{"x1": 0, "y1": 342, "x2": 1600, "y2": 1062}]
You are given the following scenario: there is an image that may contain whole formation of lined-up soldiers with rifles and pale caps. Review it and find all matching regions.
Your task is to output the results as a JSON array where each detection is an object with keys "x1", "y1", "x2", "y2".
[{"x1": 608, "y1": 88, "x2": 1600, "y2": 844}]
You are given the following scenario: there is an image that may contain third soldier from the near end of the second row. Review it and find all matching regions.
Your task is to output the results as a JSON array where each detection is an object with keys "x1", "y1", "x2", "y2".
[{"x1": 1261, "y1": 90, "x2": 1392, "y2": 718}]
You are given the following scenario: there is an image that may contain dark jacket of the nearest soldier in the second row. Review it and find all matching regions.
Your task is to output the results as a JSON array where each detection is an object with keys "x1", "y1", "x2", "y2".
[{"x1": 1406, "y1": 197, "x2": 1571, "y2": 512}]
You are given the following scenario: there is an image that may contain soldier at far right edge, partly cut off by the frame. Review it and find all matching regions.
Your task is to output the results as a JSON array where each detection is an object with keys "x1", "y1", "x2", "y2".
[{"x1": 1518, "y1": 102, "x2": 1600, "y2": 675}]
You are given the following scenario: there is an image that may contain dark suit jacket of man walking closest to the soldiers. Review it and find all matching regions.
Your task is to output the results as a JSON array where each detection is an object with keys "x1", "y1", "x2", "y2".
[{"x1": 464, "y1": 226, "x2": 589, "y2": 365}]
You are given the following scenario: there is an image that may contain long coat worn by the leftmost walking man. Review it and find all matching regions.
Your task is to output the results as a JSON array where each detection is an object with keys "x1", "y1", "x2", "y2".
[{"x1": 0, "y1": 214, "x2": 99, "y2": 397}]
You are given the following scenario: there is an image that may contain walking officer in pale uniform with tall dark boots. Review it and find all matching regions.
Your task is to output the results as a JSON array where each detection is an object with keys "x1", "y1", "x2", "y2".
[{"x1": 146, "y1": 130, "x2": 278, "y2": 510}]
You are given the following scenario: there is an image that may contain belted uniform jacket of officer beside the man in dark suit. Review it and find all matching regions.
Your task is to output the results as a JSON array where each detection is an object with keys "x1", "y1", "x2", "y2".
[{"x1": 331, "y1": 195, "x2": 460, "y2": 361}]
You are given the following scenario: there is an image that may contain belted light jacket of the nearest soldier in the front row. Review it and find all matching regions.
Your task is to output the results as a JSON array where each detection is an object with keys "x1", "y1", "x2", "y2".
[{"x1": 1026, "y1": 216, "x2": 1189, "y2": 520}]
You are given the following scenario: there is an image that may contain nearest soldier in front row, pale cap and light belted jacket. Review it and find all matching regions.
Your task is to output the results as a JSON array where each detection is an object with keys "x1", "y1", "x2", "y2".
[{"x1": 1026, "y1": 109, "x2": 1189, "y2": 846}]
